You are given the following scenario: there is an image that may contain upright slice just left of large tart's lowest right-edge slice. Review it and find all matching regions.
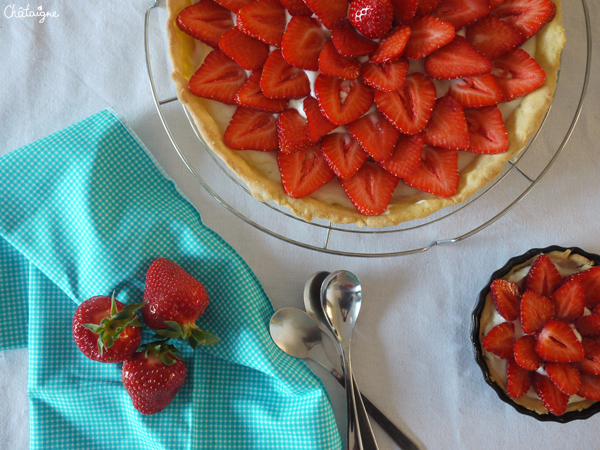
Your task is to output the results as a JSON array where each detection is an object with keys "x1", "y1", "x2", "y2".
[{"x1": 423, "y1": 95, "x2": 469, "y2": 149}]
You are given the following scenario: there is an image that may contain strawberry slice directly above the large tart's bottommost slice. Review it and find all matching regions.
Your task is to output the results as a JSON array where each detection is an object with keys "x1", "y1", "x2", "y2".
[{"x1": 348, "y1": 110, "x2": 400, "y2": 162}]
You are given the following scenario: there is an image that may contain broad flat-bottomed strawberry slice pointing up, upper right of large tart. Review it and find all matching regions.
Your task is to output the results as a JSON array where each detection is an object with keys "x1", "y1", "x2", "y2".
[{"x1": 425, "y1": 35, "x2": 492, "y2": 80}]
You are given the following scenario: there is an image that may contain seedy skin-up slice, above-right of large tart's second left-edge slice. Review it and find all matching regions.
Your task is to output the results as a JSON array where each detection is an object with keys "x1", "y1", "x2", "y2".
[{"x1": 219, "y1": 28, "x2": 269, "y2": 70}]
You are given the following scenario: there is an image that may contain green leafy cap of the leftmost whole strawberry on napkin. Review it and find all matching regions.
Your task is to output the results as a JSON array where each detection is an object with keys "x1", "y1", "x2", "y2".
[{"x1": 83, "y1": 292, "x2": 144, "y2": 356}]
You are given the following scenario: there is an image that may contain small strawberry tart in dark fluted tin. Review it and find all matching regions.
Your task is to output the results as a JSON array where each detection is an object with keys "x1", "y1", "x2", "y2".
[{"x1": 473, "y1": 247, "x2": 600, "y2": 421}]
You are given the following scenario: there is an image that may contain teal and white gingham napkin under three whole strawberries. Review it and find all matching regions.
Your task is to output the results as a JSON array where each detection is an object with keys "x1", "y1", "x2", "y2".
[{"x1": 0, "y1": 110, "x2": 342, "y2": 450}]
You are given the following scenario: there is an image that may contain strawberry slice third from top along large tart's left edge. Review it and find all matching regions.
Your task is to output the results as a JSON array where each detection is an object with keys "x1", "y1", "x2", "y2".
[{"x1": 223, "y1": 106, "x2": 278, "y2": 151}]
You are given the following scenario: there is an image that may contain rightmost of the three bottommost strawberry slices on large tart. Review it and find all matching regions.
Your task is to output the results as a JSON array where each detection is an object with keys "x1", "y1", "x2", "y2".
[{"x1": 404, "y1": 145, "x2": 459, "y2": 197}]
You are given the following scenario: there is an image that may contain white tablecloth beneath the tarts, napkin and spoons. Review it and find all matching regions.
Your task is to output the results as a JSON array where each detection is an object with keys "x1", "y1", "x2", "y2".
[{"x1": 0, "y1": 0, "x2": 600, "y2": 450}]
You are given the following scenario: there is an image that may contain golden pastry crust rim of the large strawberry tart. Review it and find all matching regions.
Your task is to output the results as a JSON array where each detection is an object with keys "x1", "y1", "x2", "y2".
[{"x1": 167, "y1": 0, "x2": 565, "y2": 227}]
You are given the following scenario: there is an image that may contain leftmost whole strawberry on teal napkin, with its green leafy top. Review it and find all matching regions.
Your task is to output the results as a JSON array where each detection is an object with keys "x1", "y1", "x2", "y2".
[{"x1": 72, "y1": 294, "x2": 142, "y2": 363}]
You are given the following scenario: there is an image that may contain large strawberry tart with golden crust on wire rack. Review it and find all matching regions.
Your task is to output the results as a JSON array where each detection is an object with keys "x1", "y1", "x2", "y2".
[{"x1": 167, "y1": 0, "x2": 565, "y2": 227}]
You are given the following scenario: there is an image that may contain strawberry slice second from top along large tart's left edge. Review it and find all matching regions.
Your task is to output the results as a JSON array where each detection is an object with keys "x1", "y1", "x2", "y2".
[{"x1": 188, "y1": 49, "x2": 247, "y2": 105}]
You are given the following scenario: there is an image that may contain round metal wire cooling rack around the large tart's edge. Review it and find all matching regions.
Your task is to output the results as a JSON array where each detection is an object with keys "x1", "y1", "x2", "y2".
[{"x1": 144, "y1": 0, "x2": 592, "y2": 258}]
